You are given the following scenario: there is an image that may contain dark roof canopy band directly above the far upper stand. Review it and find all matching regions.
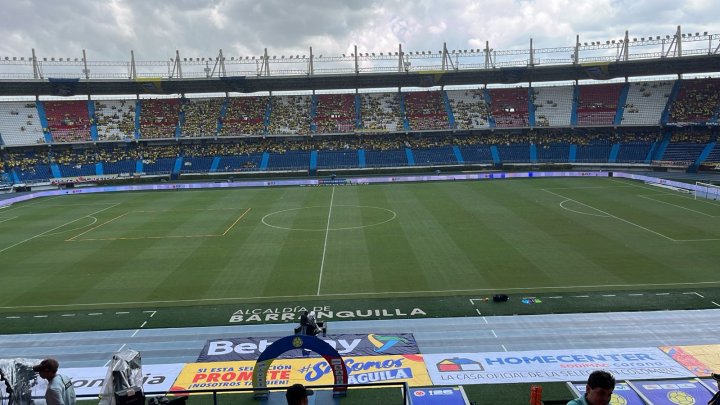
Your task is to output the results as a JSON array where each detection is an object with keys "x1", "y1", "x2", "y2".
[{"x1": 0, "y1": 54, "x2": 720, "y2": 96}]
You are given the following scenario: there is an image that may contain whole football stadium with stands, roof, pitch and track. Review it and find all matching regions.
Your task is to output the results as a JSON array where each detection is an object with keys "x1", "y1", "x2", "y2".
[{"x1": 0, "y1": 21, "x2": 720, "y2": 404}]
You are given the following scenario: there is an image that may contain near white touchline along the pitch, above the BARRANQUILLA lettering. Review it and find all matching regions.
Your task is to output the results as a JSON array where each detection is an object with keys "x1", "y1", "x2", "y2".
[{"x1": 0, "y1": 281, "x2": 720, "y2": 310}]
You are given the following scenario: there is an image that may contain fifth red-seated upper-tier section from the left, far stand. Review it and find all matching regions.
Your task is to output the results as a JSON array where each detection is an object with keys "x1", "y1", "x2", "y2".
[{"x1": 405, "y1": 91, "x2": 449, "y2": 131}]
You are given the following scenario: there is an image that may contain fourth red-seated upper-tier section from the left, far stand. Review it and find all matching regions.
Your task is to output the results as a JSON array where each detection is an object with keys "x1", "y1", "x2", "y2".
[{"x1": 313, "y1": 94, "x2": 355, "y2": 134}]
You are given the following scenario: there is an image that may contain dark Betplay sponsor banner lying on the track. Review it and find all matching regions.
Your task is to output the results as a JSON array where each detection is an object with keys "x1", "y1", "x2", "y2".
[{"x1": 197, "y1": 333, "x2": 419, "y2": 363}]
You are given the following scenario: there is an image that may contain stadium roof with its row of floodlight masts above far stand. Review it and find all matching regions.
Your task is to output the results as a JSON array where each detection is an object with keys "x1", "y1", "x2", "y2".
[{"x1": 0, "y1": 26, "x2": 720, "y2": 97}]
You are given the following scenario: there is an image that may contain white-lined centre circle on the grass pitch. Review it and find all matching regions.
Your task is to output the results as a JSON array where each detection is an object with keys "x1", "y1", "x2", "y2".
[{"x1": 262, "y1": 205, "x2": 397, "y2": 232}]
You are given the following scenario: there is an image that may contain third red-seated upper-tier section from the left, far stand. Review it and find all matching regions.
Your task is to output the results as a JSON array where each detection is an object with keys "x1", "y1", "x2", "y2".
[{"x1": 220, "y1": 97, "x2": 269, "y2": 136}]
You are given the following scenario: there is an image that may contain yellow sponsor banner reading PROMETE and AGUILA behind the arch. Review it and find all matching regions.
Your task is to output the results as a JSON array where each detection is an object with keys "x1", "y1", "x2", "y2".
[{"x1": 173, "y1": 355, "x2": 431, "y2": 391}]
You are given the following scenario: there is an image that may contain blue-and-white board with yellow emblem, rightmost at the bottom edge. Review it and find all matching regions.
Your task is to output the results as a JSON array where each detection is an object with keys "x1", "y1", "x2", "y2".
[{"x1": 632, "y1": 381, "x2": 712, "y2": 405}]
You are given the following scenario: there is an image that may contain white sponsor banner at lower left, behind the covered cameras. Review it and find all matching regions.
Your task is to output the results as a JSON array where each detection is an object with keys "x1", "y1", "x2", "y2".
[{"x1": 0, "y1": 364, "x2": 185, "y2": 398}]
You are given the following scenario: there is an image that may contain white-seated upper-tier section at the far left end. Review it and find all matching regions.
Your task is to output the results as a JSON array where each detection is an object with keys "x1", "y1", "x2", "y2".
[{"x1": 0, "y1": 102, "x2": 45, "y2": 146}]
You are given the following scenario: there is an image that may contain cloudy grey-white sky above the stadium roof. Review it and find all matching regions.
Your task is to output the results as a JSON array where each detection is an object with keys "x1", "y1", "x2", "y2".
[{"x1": 0, "y1": 0, "x2": 720, "y2": 61}]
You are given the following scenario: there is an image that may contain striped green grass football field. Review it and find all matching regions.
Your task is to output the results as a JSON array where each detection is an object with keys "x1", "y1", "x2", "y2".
[{"x1": 0, "y1": 178, "x2": 720, "y2": 333}]
